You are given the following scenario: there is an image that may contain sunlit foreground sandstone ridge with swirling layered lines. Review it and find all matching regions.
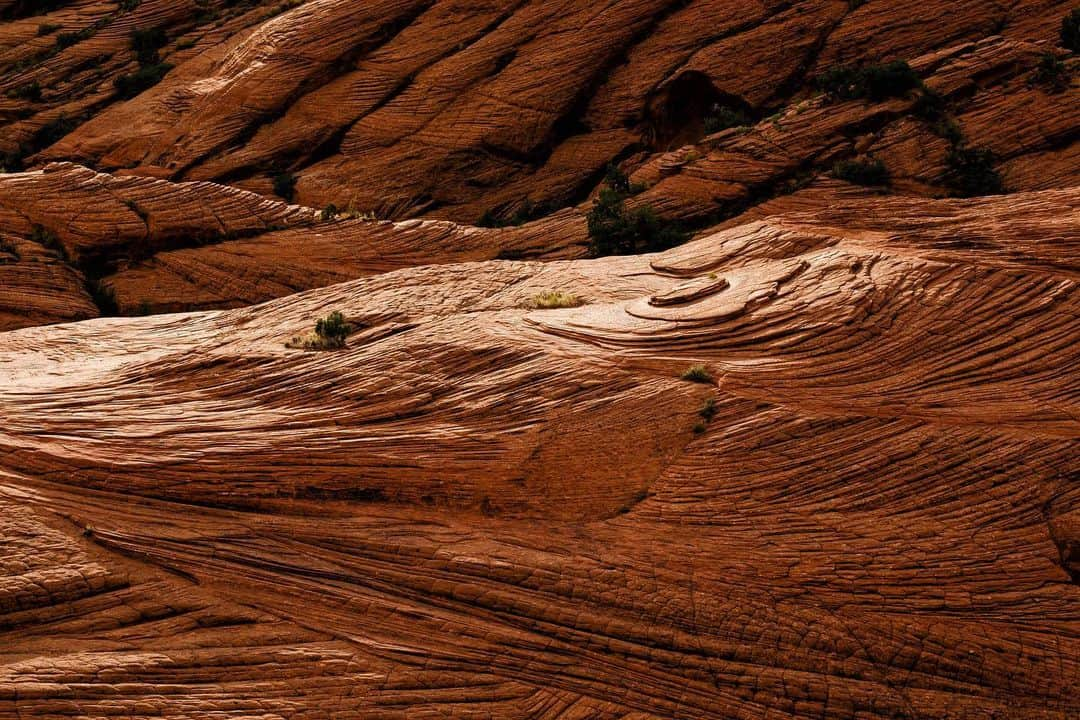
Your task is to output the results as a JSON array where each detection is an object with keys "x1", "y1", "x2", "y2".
[{"x1": 0, "y1": 189, "x2": 1080, "y2": 719}]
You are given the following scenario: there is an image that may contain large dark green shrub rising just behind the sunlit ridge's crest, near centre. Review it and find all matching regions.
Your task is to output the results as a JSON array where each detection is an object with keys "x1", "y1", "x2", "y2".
[{"x1": 586, "y1": 169, "x2": 689, "y2": 258}]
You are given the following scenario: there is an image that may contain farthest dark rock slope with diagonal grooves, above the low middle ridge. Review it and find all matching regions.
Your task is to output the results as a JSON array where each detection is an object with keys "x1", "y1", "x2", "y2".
[{"x1": 0, "y1": 0, "x2": 1080, "y2": 222}]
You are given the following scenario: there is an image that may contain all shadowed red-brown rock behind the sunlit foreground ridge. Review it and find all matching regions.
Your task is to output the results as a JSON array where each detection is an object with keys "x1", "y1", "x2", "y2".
[{"x1": 0, "y1": 0, "x2": 1080, "y2": 328}]
